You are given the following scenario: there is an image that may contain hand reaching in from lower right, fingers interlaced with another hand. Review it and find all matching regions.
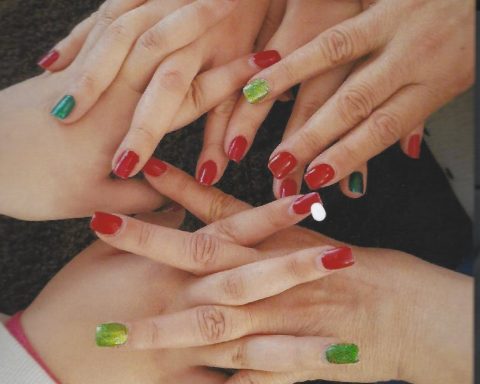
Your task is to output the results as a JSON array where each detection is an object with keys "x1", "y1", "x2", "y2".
[{"x1": 95, "y1": 160, "x2": 473, "y2": 384}]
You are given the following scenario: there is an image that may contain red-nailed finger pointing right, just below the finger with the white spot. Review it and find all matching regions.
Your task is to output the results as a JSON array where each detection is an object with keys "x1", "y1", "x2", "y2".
[{"x1": 184, "y1": 247, "x2": 355, "y2": 306}]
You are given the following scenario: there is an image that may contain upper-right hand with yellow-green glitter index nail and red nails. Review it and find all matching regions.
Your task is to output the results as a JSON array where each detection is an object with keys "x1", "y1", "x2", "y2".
[{"x1": 238, "y1": 0, "x2": 474, "y2": 194}]
